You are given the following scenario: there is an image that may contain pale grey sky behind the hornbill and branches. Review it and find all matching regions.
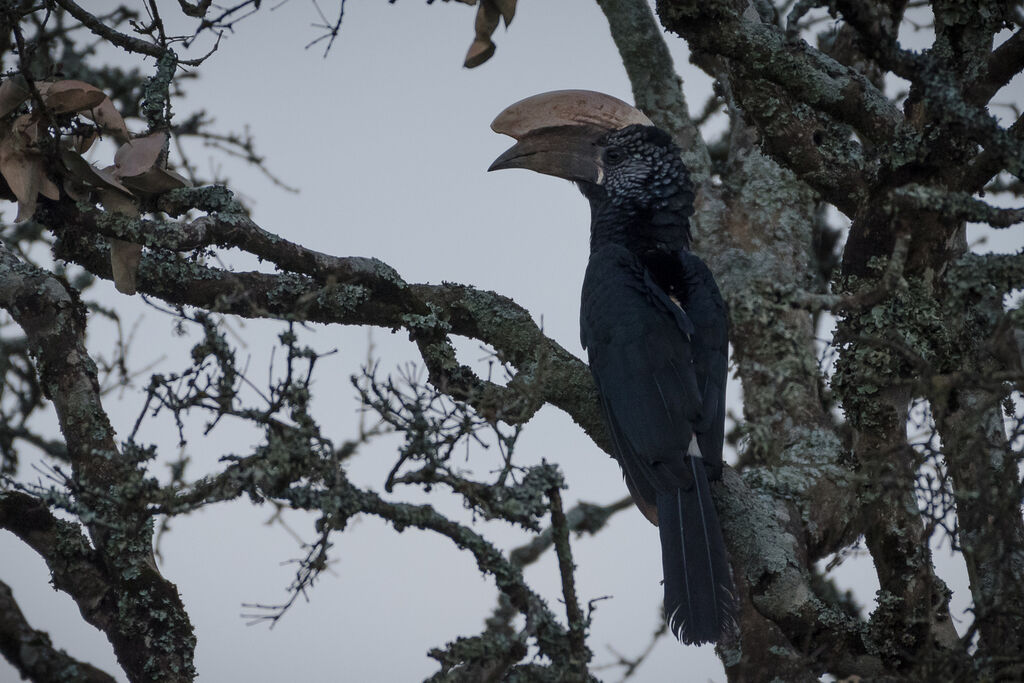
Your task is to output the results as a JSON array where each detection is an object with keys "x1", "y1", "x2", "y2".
[{"x1": 0, "y1": 0, "x2": 1015, "y2": 682}]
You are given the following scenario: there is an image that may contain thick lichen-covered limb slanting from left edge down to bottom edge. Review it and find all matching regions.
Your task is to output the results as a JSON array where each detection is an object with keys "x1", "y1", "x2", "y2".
[{"x1": 0, "y1": 243, "x2": 195, "y2": 681}]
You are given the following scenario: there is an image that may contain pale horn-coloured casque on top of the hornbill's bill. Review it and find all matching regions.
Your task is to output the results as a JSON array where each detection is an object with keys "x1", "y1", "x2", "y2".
[{"x1": 490, "y1": 90, "x2": 654, "y2": 140}]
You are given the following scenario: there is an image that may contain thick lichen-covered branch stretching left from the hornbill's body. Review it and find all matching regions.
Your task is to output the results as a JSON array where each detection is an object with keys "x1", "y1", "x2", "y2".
[{"x1": 44, "y1": 198, "x2": 608, "y2": 449}]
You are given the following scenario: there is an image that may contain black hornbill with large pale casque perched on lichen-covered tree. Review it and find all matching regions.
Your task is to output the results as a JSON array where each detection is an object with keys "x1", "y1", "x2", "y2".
[{"x1": 489, "y1": 90, "x2": 735, "y2": 643}]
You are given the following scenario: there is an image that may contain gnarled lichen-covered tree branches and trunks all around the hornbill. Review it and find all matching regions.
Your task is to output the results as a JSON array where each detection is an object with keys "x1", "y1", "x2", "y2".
[{"x1": 0, "y1": 0, "x2": 1024, "y2": 681}]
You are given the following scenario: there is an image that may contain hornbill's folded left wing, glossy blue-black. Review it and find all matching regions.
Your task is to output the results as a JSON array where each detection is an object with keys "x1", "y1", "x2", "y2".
[{"x1": 580, "y1": 246, "x2": 701, "y2": 511}]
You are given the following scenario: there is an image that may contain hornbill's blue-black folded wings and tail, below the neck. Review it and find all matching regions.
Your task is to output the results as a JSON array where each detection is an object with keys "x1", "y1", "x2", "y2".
[{"x1": 580, "y1": 247, "x2": 735, "y2": 643}]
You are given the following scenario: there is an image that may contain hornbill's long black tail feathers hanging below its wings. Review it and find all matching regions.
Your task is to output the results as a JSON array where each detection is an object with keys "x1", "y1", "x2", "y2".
[{"x1": 657, "y1": 458, "x2": 735, "y2": 644}]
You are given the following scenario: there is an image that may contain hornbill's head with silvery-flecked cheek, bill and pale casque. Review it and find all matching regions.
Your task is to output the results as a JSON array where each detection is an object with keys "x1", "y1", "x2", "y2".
[{"x1": 487, "y1": 90, "x2": 693, "y2": 249}]
